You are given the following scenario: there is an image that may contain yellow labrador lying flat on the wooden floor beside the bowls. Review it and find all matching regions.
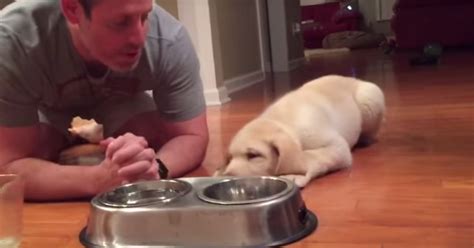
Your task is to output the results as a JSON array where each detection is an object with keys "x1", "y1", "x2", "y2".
[{"x1": 214, "y1": 75, "x2": 385, "y2": 187}]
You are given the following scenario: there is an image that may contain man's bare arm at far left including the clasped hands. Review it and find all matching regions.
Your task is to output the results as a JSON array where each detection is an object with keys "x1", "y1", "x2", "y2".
[{"x1": 0, "y1": 124, "x2": 156, "y2": 200}]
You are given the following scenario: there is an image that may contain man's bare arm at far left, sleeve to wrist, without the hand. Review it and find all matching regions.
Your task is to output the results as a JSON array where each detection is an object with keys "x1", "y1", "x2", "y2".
[{"x1": 0, "y1": 124, "x2": 115, "y2": 200}]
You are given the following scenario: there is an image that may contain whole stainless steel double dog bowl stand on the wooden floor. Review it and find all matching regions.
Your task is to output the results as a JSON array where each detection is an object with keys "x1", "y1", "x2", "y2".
[{"x1": 80, "y1": 177, "x2": 317, "y2": 248}]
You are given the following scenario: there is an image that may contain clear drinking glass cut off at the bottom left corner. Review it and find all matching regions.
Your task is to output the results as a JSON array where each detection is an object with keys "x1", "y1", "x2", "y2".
[{"x1": 0, "y1": 174, "x2": 24, "y2": 248}]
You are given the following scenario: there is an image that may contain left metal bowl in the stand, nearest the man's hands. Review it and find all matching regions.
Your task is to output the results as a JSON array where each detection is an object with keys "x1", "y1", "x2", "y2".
[{"x1": 98, "y1": 180, "x2": 192, "y2": 208}]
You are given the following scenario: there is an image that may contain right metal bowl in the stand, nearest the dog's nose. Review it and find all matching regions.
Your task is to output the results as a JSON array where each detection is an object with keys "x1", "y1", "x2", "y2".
[{"x1": 198, "y1": 177, "x2": 294, "y2": 205}]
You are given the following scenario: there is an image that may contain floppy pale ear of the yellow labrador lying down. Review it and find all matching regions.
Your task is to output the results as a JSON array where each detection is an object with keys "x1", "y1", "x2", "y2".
[{"x1": 270, "y1": 131, "x2": 306, "y2": 175}]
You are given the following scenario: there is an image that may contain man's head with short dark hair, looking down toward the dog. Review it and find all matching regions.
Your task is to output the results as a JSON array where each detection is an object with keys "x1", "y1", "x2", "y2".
[{"x1": 61, "y1": 0, "x2": 153, "y2": 71}]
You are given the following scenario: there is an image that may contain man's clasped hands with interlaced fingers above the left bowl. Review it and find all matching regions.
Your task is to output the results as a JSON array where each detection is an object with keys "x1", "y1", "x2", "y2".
[{"x1": 101, "y1": 133, "x2": 158, "y2": 182}]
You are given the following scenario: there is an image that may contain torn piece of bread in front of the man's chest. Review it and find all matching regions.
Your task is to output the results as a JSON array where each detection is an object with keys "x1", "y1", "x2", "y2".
[{"x1": 68, "y1": 116, "x2": 104, "y2": 144}]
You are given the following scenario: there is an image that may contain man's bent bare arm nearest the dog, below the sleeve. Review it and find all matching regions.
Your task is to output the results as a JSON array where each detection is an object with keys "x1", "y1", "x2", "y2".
[{"x1": 157, "y1": 112, "x2": 209, "y2": 177}]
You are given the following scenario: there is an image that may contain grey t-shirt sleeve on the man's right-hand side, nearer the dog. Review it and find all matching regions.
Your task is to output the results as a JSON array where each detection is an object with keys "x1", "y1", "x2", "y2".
[{"x1": 153, "y1": 27, "x2": 206, "y2": 121}]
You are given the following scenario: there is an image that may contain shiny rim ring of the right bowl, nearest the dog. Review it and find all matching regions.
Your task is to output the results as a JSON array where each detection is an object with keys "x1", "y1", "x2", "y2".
[{"x1": 197, "y1": 176, "x2": 295, "y2": 205}]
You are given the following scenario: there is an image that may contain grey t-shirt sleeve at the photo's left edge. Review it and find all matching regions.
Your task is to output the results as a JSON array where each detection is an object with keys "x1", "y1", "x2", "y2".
[{"x1": 0, "y1": 26, "x2": 38, "y2": 127}]
